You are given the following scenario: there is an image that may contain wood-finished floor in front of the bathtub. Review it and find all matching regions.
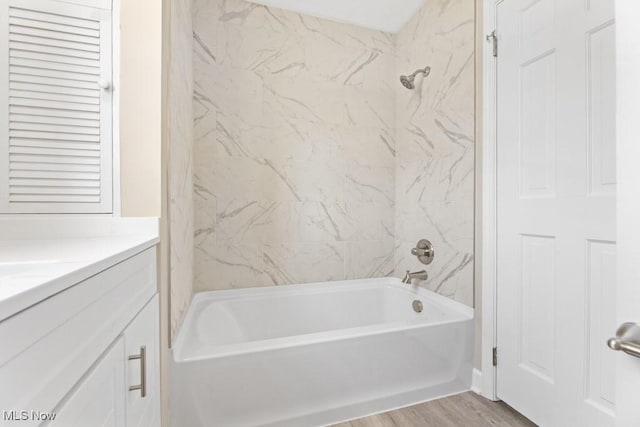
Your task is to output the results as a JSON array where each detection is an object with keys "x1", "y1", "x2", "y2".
[{"x1": 334, "y1": 392, "x2": 535, "y2": 427}]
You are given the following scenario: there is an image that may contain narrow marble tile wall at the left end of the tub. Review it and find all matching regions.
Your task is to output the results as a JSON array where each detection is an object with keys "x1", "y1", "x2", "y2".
[{"x1": 168, "y1": 0, "x2": 194, "y2": 336}]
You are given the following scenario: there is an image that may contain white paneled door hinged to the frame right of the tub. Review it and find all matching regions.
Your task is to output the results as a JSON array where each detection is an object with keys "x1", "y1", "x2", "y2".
[{"x1": 497, "y1": 0, "x2": 617, "y2": 427}]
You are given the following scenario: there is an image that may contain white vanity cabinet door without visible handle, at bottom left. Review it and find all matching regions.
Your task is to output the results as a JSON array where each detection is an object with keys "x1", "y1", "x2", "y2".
[{"x1": 47, "y1": 338, "x2": 126, "y2": 427}]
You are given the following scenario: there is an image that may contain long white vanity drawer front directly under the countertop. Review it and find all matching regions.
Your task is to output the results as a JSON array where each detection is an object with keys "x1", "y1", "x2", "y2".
[{"x1": 0, "y1": 248, "x2": 157, "y2": 425}]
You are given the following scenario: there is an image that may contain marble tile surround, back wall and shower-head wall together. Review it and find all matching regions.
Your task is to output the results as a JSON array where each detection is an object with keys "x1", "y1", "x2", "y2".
[{"x1": 192, "y1": 0, "x2": 474, "y2": 305}]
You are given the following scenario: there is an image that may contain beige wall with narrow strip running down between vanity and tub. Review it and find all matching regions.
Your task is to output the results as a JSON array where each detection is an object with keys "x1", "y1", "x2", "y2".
[{"x1": 119, "y1": 0, "x2": 169, "y2": 425}]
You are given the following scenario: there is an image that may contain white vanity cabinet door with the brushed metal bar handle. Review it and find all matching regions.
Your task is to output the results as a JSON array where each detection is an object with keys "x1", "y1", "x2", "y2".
[{"x1": 124, "y1": 295, "x2": 160, "y2": 427}]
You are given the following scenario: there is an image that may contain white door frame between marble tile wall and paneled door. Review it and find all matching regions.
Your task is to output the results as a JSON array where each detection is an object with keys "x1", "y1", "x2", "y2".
[{"x1": 476, "y1": 0, "x2": 504, "y2": 400}]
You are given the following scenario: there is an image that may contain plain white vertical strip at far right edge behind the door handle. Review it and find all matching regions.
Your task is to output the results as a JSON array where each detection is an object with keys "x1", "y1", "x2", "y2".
[{"x1": 611, "y1": 0, "x2": 640, "y2": 426}]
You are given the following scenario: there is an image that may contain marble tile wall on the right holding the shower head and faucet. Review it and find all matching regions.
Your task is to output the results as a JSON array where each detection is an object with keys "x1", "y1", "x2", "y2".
[{"x1": 394, "y1": 0, "x2": 475, "y2": 306}]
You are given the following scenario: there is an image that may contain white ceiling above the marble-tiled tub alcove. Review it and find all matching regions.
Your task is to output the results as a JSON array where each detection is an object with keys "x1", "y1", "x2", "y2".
[{"x1": 248, "y1": 0, "x2": 425, "y2": 33}]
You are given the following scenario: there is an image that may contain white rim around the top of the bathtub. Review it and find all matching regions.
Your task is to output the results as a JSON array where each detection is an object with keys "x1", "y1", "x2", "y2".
[{"x1": 171, "y1": 278, "x2": 474, "y2": 363}]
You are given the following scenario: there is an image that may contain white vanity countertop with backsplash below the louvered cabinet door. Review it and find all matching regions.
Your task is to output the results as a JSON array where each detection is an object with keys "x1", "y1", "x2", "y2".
[{"x1": 0, "y1": 218, "x2": 159, "y2": 321}]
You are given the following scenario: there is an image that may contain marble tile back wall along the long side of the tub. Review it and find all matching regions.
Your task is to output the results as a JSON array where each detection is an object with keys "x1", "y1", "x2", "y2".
[{"x1": 193, "y1": 0, "x2": 397, "y2": 291}]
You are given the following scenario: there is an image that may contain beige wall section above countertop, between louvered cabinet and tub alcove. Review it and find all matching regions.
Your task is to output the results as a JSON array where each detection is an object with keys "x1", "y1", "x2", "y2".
[{"x1": 119, "y1": 0, "x2": 162, "y2": 216}]
